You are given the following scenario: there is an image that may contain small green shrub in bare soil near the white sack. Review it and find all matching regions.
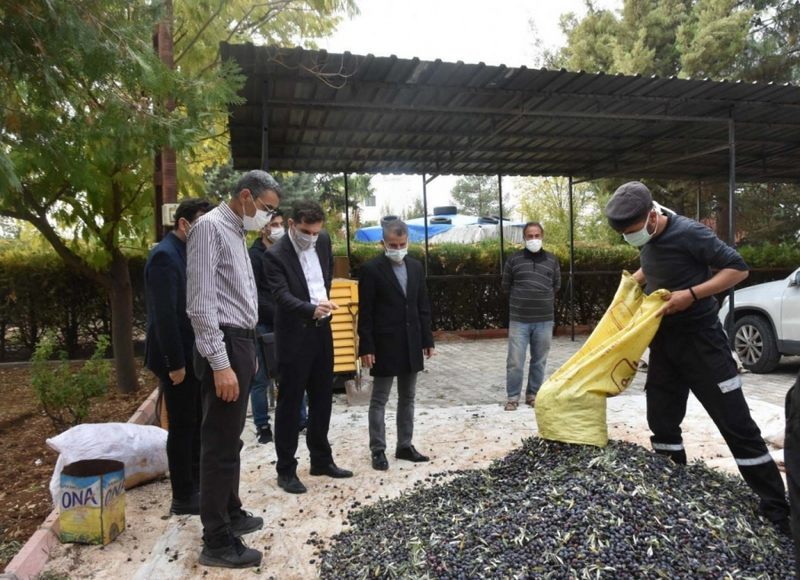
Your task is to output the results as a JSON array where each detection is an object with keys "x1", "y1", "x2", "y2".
[{"x1": 31, "y1": 335, "x2": 111, "y2": 431}]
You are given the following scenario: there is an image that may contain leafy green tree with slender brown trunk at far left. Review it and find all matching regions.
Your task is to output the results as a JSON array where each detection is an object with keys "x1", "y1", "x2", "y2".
[{"x1": 0, "y1": 0, "x2": 241, "y2": 392}]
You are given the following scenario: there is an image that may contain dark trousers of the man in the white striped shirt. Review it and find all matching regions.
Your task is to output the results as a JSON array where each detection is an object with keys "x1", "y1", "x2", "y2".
[{"x1": 196, "y1": 333, "x2": 256, "y2": 548}]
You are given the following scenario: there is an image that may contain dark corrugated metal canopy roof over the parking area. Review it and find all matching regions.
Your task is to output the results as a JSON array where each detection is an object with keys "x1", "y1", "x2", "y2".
[{"x1": 221, "y1": 43, "x2": 800, "y2": 182}]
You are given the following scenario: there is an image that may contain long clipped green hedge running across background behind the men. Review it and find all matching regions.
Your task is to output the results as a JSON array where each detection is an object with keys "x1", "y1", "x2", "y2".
[{"x1": 0, "y1": 242, "x2": 800, "y2": 360}]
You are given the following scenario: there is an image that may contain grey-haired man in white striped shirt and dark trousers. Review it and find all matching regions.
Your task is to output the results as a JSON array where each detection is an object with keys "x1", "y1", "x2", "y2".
[{"x1": 186, "y1": 170, "x2": 280, "y2": 568}]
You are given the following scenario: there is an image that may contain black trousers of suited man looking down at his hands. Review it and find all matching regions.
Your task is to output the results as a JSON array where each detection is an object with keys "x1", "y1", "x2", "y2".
[{"x1": 275, "y1": 324, "x2": 333, "y2": 475}]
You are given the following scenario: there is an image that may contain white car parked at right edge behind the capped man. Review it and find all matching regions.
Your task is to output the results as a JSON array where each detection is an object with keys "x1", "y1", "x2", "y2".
[{"x1": 719, "y1": 268, "x2": 800, "y2": 373}]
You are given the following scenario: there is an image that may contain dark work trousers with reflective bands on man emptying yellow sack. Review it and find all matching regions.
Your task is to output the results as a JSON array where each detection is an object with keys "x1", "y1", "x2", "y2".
[{"x1": 645, "y1": 322, "x2": 789, "y2": 521}]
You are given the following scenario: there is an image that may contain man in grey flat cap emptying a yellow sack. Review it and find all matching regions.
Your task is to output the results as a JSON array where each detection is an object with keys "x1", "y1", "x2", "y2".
[{"x1": 606, "y1": 181, "x2": 789, "y2": 534}]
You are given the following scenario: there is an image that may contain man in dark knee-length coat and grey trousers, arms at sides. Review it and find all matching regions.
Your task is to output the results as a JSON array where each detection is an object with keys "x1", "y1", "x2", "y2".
[{"x1": 358, "y1": 220, "x2": 434, "y2": 471}]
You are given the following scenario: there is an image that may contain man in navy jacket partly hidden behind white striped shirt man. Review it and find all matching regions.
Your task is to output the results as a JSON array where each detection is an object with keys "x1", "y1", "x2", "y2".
[{"x1": 144, "y1": 199, "x2": 214, "y2": 515}]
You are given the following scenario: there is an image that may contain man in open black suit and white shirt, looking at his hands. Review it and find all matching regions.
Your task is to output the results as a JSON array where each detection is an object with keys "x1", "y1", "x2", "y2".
[{"x1": 266, "y1": 200, "x2": 353, "y2": 493}]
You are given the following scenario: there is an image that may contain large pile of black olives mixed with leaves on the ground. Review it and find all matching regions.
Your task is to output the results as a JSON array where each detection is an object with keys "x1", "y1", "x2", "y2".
[{"x1": 320, "y1": 438, "x2": 794, "y2": 580}]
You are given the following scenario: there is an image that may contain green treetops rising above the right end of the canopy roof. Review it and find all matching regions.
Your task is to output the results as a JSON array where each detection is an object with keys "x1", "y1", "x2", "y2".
[{"x1": 552, "y1": 0, "x2": 800, "y2": 82}]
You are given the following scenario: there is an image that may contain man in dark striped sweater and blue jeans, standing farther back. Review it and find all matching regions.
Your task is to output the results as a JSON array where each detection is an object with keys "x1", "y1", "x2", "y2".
[{"x1": 502, "y1": 222, "x2": 561, "y2": 411}]
